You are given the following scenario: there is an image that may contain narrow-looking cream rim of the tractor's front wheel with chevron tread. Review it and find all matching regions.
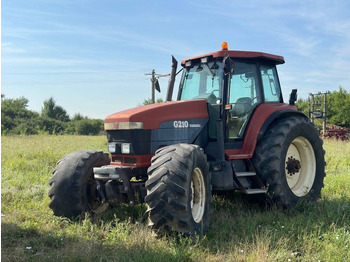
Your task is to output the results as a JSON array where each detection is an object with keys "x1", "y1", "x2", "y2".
[{"x1": 191, "y1": 167, "x2": 206, "y2": 223}]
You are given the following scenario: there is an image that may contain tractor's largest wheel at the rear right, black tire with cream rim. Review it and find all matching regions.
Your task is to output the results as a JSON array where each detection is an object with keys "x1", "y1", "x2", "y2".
[{"x1": 252, "y1": 116, "x2": 325, "y2": 208}]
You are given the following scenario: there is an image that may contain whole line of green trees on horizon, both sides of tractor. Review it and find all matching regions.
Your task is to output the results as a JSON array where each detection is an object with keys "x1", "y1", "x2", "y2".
[{"x1": 1, "y1": 86, "x2": 350, "y2": 135}]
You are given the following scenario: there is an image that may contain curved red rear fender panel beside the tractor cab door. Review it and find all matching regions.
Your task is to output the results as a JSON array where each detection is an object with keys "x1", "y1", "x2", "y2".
[{"x1": 225, "y1": 103, "x2": 297, "y2": 160}]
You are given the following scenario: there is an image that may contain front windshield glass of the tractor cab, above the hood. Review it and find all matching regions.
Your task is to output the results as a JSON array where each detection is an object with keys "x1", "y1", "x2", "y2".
[{"x1": 179, "y1": 61, "x2": 223, "y2": 104}]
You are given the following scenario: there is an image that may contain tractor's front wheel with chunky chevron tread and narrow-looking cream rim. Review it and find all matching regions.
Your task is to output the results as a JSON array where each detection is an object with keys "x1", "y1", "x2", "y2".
[{"x1": 145, "y1": 144, "x2": 211, "y2": 235}]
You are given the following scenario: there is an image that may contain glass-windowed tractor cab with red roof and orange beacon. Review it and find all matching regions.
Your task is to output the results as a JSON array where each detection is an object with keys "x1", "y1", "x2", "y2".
[{"x1": 177, "y1": 42, "x2": 284, "y2": 142}]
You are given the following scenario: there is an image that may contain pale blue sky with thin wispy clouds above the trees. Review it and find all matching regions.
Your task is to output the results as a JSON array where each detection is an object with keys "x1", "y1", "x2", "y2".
[{"x1": 1, "y1": 0, "x2": 350, "y2": 119}]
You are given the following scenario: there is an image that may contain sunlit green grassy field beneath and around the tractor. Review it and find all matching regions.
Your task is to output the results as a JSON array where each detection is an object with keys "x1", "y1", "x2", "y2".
[{"x1": 1, "y1": 136, "x2": 350, "y2": 262}]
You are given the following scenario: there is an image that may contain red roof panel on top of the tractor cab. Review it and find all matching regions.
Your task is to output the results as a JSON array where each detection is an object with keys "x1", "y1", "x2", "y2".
[{"x1": 181, "y1": 50, "x2": 284, "y2": 66}]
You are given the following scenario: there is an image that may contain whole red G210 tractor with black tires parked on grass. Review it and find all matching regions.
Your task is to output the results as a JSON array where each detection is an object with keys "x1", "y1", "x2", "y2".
[{"x1": 49, "y1": 42, "x2": 325, "y2": 235}]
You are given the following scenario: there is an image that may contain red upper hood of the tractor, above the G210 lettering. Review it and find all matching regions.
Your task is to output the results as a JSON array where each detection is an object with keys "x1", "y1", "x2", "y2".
[{"x1": 105, "y1": 99, "x2": 209, "y2": 129}]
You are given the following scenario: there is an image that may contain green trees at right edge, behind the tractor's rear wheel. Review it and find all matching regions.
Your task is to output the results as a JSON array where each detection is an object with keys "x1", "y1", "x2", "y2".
[{"x1": 296, "y1": 86, "x2": 350, "y2": 128}]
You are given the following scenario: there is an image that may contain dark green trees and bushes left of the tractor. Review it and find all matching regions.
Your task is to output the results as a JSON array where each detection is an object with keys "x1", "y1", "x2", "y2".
[{"x1": 1, "y1": 94, "x2": 103, "y2": 135}]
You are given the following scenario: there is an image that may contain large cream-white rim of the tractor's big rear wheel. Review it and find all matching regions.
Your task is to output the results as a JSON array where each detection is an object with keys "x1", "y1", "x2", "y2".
[{"x1": 285, "y1": 136, "x2": 316, "y2": 197}]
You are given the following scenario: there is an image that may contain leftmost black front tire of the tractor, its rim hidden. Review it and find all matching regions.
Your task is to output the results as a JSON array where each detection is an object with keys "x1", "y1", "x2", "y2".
[{"x1": 49, "y1": 150, "x2": 110, "y2": 218}]
